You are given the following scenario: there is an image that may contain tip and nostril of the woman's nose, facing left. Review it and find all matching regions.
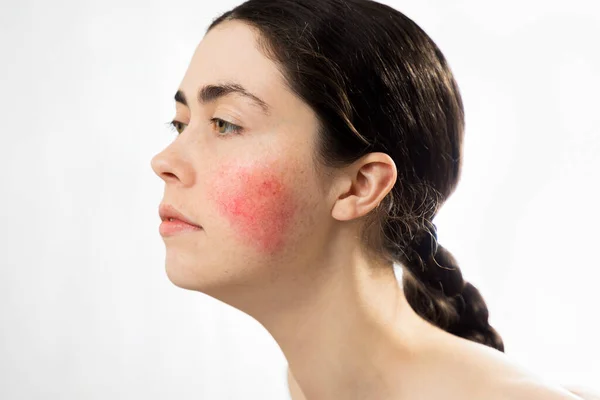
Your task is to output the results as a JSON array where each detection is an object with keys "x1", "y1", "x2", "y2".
[{"x1": 150, "y1": 142, "x2": 195, "y2": 186}]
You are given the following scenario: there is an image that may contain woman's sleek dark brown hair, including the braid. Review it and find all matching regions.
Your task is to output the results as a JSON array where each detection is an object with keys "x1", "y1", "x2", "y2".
[{"x1": 208, "y1": 0, "x2": 504, "y2": 351}]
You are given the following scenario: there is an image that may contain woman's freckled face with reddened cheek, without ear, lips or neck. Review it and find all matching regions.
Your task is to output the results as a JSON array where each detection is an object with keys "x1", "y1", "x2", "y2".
[{"x1": 152, "y1": 21, "x2": 331, "y2": 296}]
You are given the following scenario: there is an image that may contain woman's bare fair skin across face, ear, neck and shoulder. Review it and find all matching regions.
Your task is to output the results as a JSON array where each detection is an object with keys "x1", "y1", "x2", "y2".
[{"x1": 152, "y1": 21, "x2": 592, "y2": 400}]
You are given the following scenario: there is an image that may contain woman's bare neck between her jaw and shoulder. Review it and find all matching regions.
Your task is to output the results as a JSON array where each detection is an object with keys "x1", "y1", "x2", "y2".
[{"x1": 232, "y1": 244, "x2": 437, "y2": 400}]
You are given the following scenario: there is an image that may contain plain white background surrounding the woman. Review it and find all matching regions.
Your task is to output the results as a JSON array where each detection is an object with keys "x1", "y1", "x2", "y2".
[{"x1": 0, "y1": 0, "x2": 600, "y2": 400}]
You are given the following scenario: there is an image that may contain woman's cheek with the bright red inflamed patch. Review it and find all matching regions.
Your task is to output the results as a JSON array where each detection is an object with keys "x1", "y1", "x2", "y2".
[{"x1": 208, "y1": 161, "x2": 297, "y2": 254}]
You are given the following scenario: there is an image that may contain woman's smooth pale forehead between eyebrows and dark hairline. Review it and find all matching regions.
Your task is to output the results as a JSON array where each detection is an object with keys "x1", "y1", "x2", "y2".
[{"x1": 180, "y1": 21, "x2": 285, "y2": 108}]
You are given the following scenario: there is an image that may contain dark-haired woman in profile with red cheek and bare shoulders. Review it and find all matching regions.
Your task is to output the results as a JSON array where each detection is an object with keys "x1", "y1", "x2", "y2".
[{"x1": 152, "y1": 0, "x2": 591, "y2": 400}]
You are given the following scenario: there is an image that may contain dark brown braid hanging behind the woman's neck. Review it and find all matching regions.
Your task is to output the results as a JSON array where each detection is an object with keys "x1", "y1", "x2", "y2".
[{"x1": 403, "y1": 221, "x2": 504, "y2": 352}]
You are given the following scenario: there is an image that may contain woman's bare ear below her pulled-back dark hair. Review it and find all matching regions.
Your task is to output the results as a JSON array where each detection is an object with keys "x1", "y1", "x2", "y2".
[{"x1": 331, "y1": 153, "x2": 397, "y2": 221}]
